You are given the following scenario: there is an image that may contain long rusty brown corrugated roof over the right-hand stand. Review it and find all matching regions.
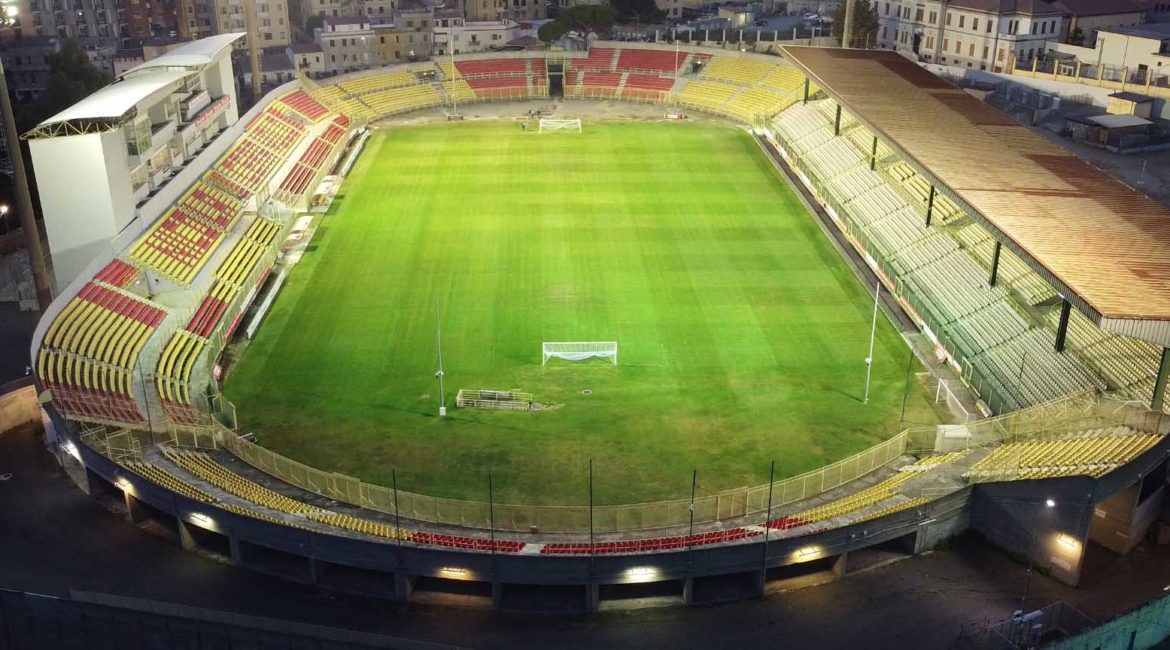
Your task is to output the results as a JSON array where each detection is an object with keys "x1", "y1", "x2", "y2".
[{"x1": 782, "y1": 47, "x2": 1170, "y2": 346}]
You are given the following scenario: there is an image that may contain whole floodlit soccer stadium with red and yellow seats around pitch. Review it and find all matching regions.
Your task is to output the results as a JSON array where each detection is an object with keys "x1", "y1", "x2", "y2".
[{"x1": 13, "y1": 34, "x2": 1170, "y2": 610}]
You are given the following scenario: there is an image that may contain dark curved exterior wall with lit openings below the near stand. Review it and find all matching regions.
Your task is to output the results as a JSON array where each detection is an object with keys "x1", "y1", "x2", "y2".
[{"x1": 48, "y1": 407, "x2": 971, "y2": 610}]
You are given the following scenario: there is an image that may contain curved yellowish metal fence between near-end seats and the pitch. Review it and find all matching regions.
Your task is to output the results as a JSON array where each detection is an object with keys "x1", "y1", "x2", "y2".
[{"x1": 109, "y1": 394, "x2": 1141, "y2": 533}]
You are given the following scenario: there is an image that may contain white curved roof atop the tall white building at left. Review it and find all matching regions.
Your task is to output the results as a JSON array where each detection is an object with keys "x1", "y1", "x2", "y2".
[{"x1": 29, "y1": 70, "x2": 195, "y2": 138}]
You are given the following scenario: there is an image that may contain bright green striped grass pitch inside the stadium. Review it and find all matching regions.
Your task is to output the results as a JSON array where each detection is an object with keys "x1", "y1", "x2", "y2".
[{"x1": 225, "y1": 123, "x2": 937, "y2": 504}]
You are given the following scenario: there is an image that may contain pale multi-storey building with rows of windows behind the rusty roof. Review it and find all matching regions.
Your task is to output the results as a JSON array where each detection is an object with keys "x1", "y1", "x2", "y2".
[{"x1": 879, "y1": 0, "x2": 1064, "y2": 71}]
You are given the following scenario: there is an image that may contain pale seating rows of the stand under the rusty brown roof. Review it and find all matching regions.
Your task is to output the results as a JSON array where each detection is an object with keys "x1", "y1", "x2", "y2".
[{"x1": 772, "y1": 101, "x2": 1106, "y2": 410}]
